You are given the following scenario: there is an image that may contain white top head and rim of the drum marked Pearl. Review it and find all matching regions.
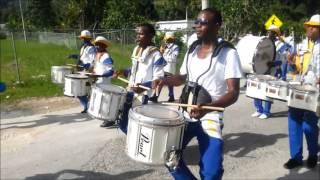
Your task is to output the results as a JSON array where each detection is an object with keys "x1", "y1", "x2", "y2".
[{"x1": 129, "y1": 105, "x2": 184, "y2": 126}]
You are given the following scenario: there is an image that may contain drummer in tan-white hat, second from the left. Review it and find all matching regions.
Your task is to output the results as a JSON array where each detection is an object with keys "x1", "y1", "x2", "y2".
[{"x1": 89, "y1": 36, "x2": 114, "y2": 127}]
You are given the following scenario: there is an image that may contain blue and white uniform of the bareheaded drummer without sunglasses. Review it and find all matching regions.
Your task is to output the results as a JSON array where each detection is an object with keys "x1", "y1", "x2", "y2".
[{"x1": 119, "y1": 46, "x2": 166, "y2": 133}]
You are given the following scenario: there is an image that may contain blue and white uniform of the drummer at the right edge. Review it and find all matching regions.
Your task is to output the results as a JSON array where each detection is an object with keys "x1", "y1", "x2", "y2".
[{"x1": 288, "y1": 39, "x2": 320, "y2": 162}]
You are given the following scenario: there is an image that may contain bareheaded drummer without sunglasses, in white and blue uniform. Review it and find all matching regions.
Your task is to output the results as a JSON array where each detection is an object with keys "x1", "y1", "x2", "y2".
[{"x1": 115, "y1": 23, "x2": 166, "y2": 133}]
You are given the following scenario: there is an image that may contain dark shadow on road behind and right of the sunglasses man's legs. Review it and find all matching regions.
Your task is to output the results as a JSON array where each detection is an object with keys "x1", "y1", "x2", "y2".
[{"x1": 184, "y1": 133, "x2": 287, "y2": 165}]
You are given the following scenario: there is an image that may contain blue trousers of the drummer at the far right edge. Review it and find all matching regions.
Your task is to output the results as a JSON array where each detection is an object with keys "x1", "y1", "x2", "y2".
[{"x1": 288, "y1": 107, "x2": 319, "y2": 162}]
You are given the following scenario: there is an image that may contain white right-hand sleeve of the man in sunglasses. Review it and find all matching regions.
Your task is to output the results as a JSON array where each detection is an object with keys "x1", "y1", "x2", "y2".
[{"x1": 224, "y1": 49, "x2": 242, "y2": 79}]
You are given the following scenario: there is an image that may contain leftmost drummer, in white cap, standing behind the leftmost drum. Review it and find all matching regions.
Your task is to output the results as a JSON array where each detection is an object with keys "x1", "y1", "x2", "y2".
[{"x1": 71, "y1": 30, "x2": 96, "y2": 113}]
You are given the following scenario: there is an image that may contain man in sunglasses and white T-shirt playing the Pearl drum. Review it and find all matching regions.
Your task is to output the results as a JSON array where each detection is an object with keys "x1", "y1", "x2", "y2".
[{"x1": 155, "y1": 8, "x2": 242, "y2": 180}]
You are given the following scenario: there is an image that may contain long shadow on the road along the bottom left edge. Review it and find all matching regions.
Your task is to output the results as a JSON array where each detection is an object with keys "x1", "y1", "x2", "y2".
[{"x1": 25, "y1": 170, "x2": 153, "y2": 180}]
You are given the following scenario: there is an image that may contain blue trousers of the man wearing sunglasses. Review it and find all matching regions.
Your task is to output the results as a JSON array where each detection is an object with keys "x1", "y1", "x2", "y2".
[{"x1": 170, "y1": 121, "x2": 223, "y2": 180}]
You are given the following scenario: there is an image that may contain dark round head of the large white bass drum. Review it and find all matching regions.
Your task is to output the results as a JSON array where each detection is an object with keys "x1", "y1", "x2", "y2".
[{"x1": 253, "y1": 37, "x2": 276, "y2": 74}]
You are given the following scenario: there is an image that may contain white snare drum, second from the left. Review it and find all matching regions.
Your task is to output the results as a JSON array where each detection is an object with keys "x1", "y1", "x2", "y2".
[{"x1": 64, "y1": 74, "x2": 90, "y2": 97}]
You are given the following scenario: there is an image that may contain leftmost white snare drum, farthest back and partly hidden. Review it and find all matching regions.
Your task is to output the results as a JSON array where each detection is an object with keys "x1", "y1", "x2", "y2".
[{"x1": 51, "y1": 66, "x2": 73, "y2": 84}]
